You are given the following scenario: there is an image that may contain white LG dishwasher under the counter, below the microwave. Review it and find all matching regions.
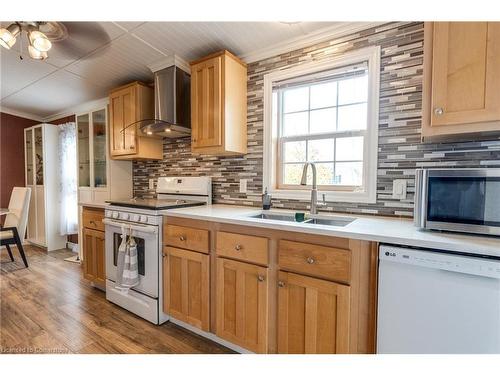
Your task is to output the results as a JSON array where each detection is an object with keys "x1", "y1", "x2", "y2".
[{"x1": 377, "y1": 245, "x2": 500, "y2": 354}]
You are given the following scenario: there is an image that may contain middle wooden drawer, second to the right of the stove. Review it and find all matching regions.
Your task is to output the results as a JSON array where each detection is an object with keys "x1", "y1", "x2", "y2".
[{"x1": 216, "y1": 232, "x2": 269, "y2": 266}]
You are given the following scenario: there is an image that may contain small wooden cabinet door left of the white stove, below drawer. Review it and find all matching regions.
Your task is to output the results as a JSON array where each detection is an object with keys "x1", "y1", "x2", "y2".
[{"x1": 83, "y1": 228, "x2": 106, "y2": 287}]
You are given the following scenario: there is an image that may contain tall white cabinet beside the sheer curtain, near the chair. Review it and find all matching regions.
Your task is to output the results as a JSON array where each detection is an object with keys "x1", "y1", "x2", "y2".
[{"x1": 24, "y1": 124, "x2": 66, "y2": 251}]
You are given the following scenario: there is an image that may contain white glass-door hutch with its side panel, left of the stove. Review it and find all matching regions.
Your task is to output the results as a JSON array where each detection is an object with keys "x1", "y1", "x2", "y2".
[{"x1": 76, "y1": 107, "x2": 132, "y2": 203}]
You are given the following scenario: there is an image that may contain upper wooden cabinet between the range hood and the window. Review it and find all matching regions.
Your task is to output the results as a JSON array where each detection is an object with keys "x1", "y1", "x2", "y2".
[{"x1": 191, "y1": 51, "x2": 247, "y2": 155}]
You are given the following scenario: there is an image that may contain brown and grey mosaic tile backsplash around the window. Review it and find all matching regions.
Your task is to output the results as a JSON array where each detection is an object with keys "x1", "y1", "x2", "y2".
[{"x1": 133, "y1": 22, "x2": 500, "y2": 216}]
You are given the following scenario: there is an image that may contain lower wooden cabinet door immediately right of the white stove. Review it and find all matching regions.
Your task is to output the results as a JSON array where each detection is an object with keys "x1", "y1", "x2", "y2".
[{"x1": 163, "y1": 247, "x2": 210, "y2": 331}]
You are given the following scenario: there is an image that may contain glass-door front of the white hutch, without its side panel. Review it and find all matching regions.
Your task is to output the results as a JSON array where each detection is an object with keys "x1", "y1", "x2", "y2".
[{"x1": 76, "y1": 108, "x2": 108, "y2": 202}]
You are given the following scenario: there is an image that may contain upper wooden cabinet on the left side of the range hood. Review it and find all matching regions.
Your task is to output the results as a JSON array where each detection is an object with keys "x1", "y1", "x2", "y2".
[{"x1": 109, "y1": 82, "x2": 163, "y2": 160}]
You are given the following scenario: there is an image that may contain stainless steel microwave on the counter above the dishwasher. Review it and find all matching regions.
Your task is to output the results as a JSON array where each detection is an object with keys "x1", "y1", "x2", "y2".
[{"x1": 414, "y1": 168, "x2": 500, "y2": 236}]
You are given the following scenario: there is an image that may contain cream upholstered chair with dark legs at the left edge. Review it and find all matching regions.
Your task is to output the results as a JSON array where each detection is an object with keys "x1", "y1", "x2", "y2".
[{"x1": 0, "y1": 187, "x2": 31, "y2": 267}]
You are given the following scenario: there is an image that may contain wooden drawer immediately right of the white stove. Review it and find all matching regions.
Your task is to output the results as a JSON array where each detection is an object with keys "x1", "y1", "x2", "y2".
[{"x1": 163, "y1": 224, "x2": 210, "y2": 254}]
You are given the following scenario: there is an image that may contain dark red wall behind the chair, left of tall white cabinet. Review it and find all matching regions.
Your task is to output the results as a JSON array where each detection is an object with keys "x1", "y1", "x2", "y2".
[{"x1": 0, "y1": 112, "x2": 38, "y2": 207}]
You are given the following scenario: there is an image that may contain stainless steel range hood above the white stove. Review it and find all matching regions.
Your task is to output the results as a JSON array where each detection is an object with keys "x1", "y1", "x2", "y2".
[{"x1": 140, "y1": 56, "x2": 191, "y2": 138}]
